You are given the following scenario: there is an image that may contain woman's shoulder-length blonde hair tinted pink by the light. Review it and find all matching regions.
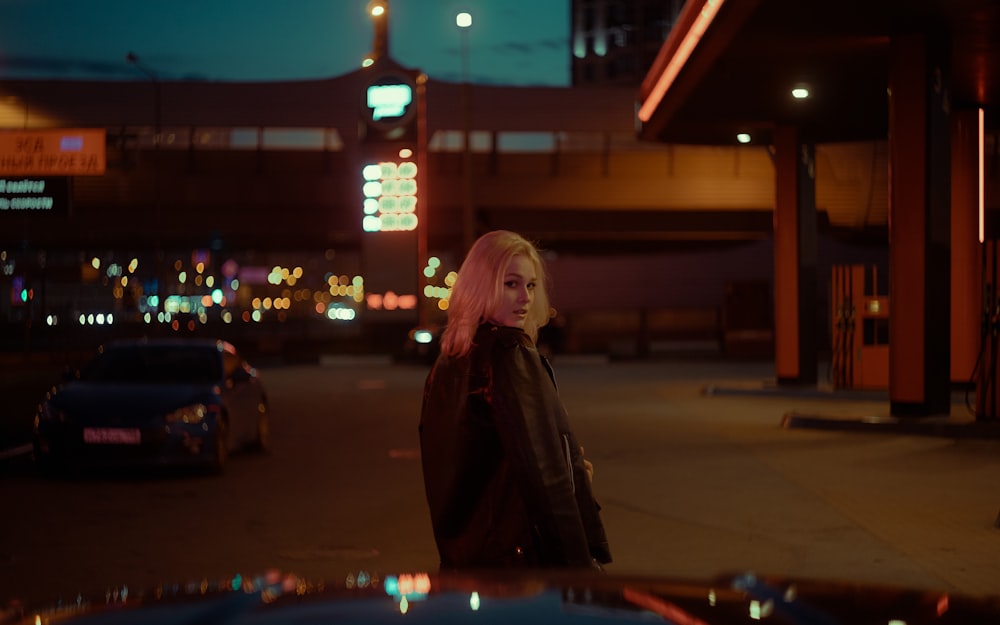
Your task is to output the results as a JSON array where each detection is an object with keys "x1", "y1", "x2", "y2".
[{"x1": 441, "y1": 230, "x2": 550, "y2": 356}]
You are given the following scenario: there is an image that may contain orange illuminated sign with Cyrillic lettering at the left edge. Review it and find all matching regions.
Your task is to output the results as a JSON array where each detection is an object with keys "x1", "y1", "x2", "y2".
[{"x1": 0, "y1": 128, "x2": 107, "y2": 176}]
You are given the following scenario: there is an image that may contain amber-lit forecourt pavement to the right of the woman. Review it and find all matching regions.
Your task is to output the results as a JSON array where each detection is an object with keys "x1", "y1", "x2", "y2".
[{"x1": 555, "y1": 359, "x2": 1000, "y2": 595}]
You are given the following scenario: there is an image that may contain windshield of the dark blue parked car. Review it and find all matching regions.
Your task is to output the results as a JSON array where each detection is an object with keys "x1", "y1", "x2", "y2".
[{"x1": 80, "y1": 345, "x2": 221, "y2": 384}]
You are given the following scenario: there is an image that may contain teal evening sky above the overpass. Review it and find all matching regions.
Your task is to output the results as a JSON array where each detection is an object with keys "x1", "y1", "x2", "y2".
[{"x1": 0, "y1": 0, "x2": 570, "y2": 86}]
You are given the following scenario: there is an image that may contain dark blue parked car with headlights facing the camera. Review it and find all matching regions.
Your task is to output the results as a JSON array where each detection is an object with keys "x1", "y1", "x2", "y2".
[{"x1": 33, "y1": 338, "x2": 269, "y2": 474}]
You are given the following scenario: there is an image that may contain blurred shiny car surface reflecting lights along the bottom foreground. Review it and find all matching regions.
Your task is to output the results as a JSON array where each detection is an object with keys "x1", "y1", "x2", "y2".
[{"x1": 7, "y1": 570, "x2": 1000, "y2": 625}]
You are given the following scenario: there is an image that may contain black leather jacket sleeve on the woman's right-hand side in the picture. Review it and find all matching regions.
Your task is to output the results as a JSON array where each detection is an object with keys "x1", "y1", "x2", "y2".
[{"x1": 491, "y1": 330, "x2": 593, "y2": 566}]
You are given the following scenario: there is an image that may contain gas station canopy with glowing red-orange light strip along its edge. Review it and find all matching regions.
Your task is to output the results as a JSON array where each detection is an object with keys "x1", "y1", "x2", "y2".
[{"x1": 638, "y1": 0, "x2": 1000, "y2": 145}]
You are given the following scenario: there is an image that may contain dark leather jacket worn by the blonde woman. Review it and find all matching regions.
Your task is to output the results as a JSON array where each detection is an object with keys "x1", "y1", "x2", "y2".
[{"x1": 420, "y1": 324, "x2": 611, "y2": 568}]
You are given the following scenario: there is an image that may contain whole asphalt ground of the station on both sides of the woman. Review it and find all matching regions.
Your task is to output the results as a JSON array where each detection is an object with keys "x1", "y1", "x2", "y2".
[{"x1": 0, "y1": 359, "x2": 1000, "y2": 605}]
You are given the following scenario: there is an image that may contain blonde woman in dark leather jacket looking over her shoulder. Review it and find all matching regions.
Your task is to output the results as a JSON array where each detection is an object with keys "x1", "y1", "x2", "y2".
[{"x1": 420, "y1": 230, "x2": 611, "y2": 568}]
